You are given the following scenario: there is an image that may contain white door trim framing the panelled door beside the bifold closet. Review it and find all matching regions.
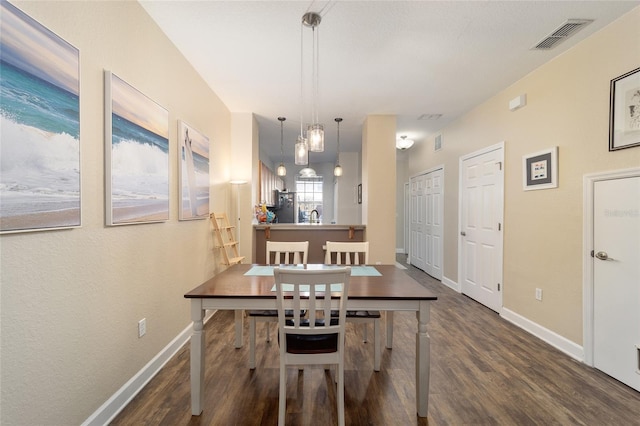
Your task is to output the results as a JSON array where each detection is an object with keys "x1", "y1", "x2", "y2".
[{"x1": 456, "y1": 141, "x2": 507, "y2": 314}]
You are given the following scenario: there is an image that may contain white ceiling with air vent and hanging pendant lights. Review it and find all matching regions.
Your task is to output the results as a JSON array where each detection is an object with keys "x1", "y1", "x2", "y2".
[{"x1": 140, "y1": 0, "x2": 640, "y2": 165}]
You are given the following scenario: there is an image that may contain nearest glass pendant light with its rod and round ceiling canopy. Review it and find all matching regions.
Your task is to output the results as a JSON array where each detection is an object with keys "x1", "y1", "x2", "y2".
[{"x1": 301, "y1": 12, "x2": 324, "y2": 152}]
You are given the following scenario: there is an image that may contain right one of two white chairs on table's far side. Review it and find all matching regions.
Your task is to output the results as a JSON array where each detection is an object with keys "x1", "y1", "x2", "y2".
[{"x1": 324, "y1": 241, "x2": 381, "y2": 371}]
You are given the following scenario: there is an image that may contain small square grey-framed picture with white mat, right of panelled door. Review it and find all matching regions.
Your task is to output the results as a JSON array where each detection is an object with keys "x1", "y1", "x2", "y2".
[{"x1": 522, "y1": 146, "x2": 558, "y2": 191}]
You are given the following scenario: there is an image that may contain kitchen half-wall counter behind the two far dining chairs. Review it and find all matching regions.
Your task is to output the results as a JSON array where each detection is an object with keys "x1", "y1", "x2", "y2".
[{"x1": 252, "y1": 223, "x2": 366, "y2": 263}]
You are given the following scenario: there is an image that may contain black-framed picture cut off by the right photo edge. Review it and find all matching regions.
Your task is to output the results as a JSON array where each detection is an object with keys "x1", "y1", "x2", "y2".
[{"x1": 609, "y1": 68, "x2": 640, "y2": 151}]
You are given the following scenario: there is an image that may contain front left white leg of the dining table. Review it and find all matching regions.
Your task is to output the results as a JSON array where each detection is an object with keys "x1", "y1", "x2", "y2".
[{"x1": 191, "y1": 299, "x2": 205, "y2": 416}]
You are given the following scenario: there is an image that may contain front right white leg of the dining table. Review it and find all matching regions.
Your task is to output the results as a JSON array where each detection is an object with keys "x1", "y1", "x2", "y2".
[{"x1": 416, "y1": 301, "x2": 431, "y2": 417}]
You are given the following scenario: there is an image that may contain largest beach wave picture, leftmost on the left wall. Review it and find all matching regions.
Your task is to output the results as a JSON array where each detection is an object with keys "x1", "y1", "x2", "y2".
[{"x1": 0, "y1": 1, "x2": 81, "y2": 233}]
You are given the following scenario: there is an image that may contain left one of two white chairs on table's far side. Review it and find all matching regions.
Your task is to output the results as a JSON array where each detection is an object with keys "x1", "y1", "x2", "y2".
[{"x1": 247, "y1": 241, "x2": 309, "y2": 369}]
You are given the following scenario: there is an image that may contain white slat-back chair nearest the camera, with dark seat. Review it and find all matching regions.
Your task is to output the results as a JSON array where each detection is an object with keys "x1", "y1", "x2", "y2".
[{"x1": 274, "y1": 266, "x2": 351, "y2": 426}]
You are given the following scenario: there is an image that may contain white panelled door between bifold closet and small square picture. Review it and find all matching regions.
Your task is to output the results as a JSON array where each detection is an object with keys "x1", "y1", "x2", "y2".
[{"x1": 458, "y1": 144, "x2": 504, "y2": 312}]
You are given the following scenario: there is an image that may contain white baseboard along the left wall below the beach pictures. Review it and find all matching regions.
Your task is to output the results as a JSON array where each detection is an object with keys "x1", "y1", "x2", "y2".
[{"x1": 82, "y1": 311, "x2": 215, "y2": 426}]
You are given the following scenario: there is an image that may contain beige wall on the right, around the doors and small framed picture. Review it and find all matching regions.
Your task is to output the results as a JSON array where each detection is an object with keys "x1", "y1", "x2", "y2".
[{"x1": 409, "y1": 8, "x2": 640, "y2": 345}]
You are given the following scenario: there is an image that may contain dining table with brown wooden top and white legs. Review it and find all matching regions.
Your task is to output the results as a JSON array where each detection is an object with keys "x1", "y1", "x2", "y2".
[{"x1": 184, "y1": 264, "x2": 437, "y2": 417}]
